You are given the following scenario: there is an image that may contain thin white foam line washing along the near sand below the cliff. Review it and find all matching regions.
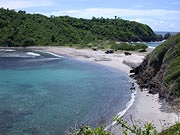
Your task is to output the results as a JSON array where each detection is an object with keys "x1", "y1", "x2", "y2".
[{"x1": 105, "y1": 82, "x2": 138, "y2": 131}]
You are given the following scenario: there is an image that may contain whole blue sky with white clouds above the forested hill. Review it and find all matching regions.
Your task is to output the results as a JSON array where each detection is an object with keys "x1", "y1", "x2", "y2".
[{"x1": 0, "y1": 0, "x2": 180, "y2": 32}]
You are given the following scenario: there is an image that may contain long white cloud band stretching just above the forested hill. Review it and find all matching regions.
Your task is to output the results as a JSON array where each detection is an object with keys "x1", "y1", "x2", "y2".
[{"x1": 46, "y1": 8, "x2": 180, "y2": 18}]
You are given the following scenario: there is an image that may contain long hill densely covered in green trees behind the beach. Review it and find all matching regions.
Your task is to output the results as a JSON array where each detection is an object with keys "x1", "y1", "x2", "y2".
[{"x1": 0, "y1": 8, "x2": 162, "y2": 46}]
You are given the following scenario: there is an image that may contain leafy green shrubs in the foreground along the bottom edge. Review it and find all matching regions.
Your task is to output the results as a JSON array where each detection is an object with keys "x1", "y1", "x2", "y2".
[{"x1": 68, "y1": 117, "x2": 180, "y2": 135}]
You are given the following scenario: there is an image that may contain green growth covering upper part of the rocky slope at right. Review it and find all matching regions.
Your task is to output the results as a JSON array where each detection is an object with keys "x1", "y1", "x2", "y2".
[{"x1": 158, "y1": 34, "x2": 180, "y2": 97}]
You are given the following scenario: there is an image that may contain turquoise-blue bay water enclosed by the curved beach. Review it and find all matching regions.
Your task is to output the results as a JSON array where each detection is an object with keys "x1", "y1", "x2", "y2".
[{"x1": 0, "y1": 50, "x2": 132, "y2": 135}]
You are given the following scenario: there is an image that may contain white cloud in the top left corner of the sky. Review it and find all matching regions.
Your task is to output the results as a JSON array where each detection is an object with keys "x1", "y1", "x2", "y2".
[{"x1": 0, "y1": 0, "x2": 53, "y2": 9}]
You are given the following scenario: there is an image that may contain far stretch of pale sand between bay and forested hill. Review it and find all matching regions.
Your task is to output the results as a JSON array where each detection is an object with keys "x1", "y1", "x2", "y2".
[{"x1": 29, "y1": 47, "x2": 146, "y2": 74}]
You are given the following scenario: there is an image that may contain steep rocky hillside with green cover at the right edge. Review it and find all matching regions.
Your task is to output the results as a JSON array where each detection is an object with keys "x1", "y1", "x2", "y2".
[{"x1": 131, "y1": 33, "x2": 180, "y2": 107}]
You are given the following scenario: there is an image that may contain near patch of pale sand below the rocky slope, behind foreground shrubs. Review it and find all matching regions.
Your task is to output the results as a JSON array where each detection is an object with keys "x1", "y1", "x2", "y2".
[{"x1": 110, "y1": 90, "x2": 179, "y2": 135}]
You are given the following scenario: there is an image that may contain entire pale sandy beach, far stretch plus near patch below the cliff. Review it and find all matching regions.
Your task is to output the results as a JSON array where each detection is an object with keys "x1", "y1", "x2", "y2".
[{"x1": 30, "y1": 47, "x2": 178, "y2": 135}]
